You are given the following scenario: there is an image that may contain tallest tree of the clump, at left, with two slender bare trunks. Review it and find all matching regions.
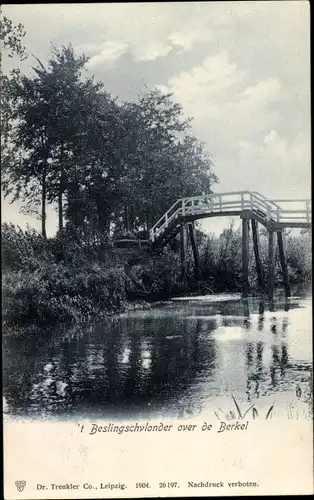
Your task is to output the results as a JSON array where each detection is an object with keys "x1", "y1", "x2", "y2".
[{"x1": 1, "y1": 46, "x2": 106, "y2": 236}]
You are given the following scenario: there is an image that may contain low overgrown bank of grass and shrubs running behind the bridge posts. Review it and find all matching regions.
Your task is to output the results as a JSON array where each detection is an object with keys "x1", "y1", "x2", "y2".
[{"x1": 2, "y1": 224, "x2": 311, "y2": 327}]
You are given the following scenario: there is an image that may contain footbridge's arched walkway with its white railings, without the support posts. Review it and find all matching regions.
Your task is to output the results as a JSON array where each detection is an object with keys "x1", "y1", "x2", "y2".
[{"x1": 150, "y1": 191, "x2": 312, "y2": 244}]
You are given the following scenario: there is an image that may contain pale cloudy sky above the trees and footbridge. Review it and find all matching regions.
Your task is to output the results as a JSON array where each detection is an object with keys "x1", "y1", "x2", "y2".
[{"x1": 2, "y1": 0, "x2": 311, "y2": 235}]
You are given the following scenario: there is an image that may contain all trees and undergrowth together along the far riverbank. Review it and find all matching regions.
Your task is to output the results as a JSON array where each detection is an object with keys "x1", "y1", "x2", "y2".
[{"x1": 1, "y1": 17, "x2": 311, "y2": 332}]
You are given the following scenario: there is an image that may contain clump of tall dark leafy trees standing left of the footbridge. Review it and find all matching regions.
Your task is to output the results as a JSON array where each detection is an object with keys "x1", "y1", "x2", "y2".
[{"x1": 3, "y1": 37, "x2": 217, "y2": 239}]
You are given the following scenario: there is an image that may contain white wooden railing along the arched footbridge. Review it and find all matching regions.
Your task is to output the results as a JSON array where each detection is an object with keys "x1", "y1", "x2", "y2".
[{"x1": 150, "y1": 191, "x2": 311, "y2": 241}]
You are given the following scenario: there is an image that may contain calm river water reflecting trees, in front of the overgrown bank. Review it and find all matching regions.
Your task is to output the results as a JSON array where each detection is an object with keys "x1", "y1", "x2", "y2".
[{"x1": 3, "y1": 294, "x2": 312, "y2": 419}]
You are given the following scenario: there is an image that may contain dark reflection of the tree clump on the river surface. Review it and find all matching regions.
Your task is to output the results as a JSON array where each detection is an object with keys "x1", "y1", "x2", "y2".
[{"x1": 5, "y1": 315, "x2": 216, "y2": 414}]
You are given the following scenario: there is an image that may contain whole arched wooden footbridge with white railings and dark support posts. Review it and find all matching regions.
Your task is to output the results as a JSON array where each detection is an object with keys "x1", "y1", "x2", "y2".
[{"x1": 149, "y1": 191, "x2": 311, "y2": 298}]
